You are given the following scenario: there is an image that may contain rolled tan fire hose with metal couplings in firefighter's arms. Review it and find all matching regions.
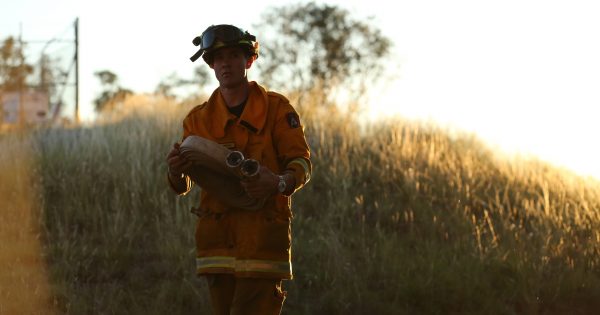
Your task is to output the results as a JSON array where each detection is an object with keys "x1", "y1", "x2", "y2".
[{"x1": 179, "y1": 135, "x2": 265, "y2": 210}]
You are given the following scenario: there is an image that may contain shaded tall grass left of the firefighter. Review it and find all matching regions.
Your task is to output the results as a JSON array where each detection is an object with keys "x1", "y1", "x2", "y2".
[{"x1": 36, "y1": 100, "x2": 207, "y2": 314}]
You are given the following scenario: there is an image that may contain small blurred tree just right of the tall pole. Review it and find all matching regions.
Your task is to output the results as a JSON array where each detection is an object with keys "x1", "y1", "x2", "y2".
[{"x1": 94, "y1": 70, "x2": 133, "y2": 112}]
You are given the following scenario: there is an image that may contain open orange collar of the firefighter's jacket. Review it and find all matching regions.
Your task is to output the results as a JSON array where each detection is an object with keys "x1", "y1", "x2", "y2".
[{"x1": 204, "y1": 81, "x2": 268, "y2": 138}]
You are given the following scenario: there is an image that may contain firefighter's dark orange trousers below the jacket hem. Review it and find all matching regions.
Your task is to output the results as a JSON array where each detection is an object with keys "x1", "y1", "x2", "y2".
[{"x1": 205, "y1": 274, "x2": 286, "y2": 315}]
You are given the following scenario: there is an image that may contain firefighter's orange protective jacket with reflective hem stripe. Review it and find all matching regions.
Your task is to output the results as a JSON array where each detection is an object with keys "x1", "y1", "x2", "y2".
[{"x1": 171, "y1": 82, "x2": 312, "y2": 279}]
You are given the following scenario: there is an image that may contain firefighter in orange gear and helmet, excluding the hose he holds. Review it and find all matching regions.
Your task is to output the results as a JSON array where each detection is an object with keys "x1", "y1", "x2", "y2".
[{"x1": 167, "y1": 24, "x2": 312, "y2": 315}]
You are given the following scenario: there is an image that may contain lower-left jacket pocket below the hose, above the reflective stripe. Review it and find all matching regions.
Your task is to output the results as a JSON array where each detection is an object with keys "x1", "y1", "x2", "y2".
[{"x1": 196, "y1": 213, "x2": 229, "y2": 250}]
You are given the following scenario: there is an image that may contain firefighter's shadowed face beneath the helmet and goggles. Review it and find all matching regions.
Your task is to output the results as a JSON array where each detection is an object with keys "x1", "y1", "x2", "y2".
[{"x1": 211, "y1": 47, "x2": 252, "y2": 88}]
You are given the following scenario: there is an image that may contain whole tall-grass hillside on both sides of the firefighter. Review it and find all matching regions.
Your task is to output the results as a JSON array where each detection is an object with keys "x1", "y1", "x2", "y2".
[{"x1": 2, "y1": 95, "x2": 600, "y2": 314}]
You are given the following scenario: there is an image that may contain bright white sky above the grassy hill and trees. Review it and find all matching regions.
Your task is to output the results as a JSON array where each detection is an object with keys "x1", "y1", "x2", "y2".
[{"x1": 0, "y1": 0, "x2": 600, "y2": 179}]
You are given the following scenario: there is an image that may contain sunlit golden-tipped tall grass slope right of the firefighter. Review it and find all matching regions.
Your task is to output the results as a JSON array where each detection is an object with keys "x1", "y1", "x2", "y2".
[{"x1": 289, "y1": 107, "x2": 600, "y2": 314}]
